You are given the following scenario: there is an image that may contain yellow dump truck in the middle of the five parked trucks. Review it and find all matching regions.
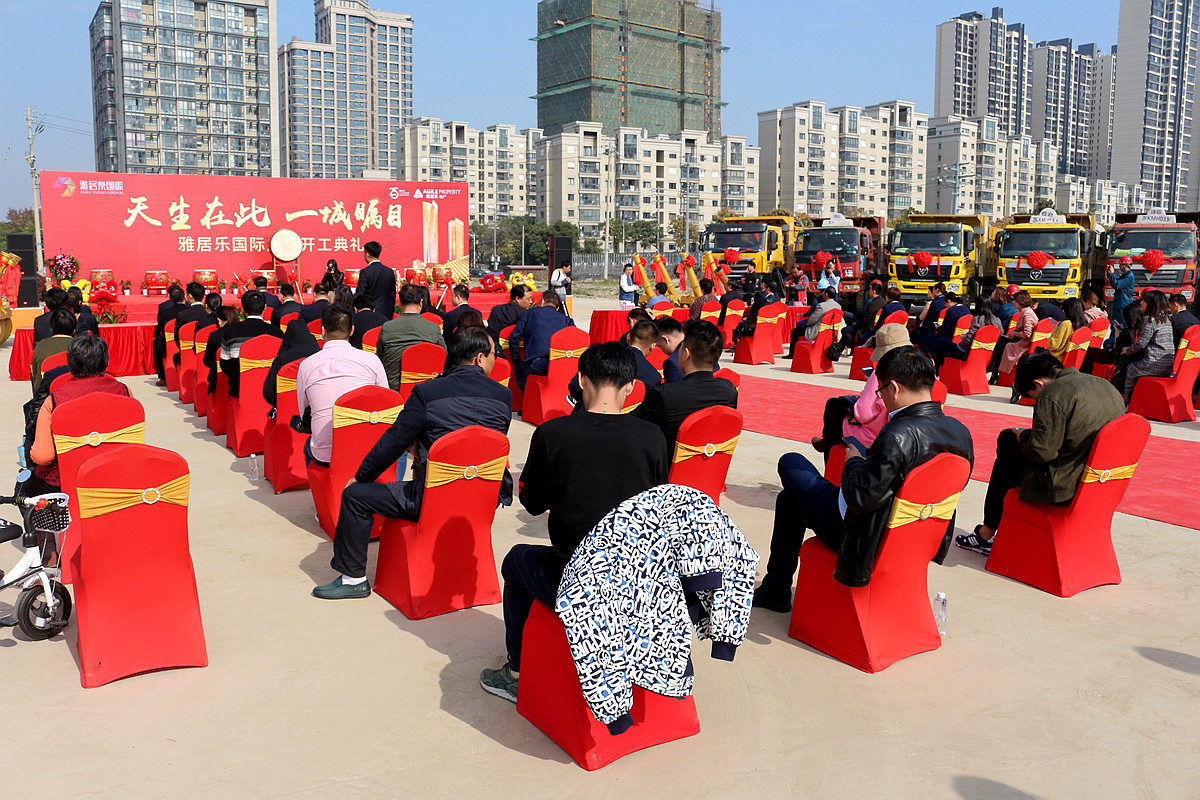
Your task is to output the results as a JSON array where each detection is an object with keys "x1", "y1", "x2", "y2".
[{"x1": 888, "y1": 213, "x2": 995, "y2": 302}]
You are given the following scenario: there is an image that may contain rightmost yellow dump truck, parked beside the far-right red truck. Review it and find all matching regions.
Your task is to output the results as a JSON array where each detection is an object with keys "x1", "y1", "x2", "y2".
[{"x1": 988, "y1": 209, "x2": 1098, "y2": 301}]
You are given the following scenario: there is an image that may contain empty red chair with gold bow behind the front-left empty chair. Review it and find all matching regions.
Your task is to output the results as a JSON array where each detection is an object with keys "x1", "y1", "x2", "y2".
[{"x1": 50, "y1": 392, "x2": 146, "y2": 584}]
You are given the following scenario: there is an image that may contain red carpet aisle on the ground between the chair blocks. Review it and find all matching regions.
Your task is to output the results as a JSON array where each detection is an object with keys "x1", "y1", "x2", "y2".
[{"x1": 738, "y1": 375, "x2": 1200, "y2": 530}]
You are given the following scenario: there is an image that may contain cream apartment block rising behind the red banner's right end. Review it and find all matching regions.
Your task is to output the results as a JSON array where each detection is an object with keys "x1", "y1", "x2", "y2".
[{"x1": 396, "y1": 116, "x2": 541, "y2": 223}]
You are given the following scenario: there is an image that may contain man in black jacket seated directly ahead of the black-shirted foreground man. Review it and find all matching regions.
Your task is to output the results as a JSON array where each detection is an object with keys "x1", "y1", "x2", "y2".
[{"x1": 632, "y1": 319, "x2": 738, "y2": 453}]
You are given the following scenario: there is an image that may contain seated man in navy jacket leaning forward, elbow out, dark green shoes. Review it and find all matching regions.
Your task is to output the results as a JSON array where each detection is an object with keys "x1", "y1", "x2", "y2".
[{"x1": 312, "y1": 327, "x2": 512, "y2": 600}]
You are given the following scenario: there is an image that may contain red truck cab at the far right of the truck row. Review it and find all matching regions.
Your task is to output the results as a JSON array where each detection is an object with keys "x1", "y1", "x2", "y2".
[{"x1": 1100, "y1": 210, "x2": 1200, "y2": 301}]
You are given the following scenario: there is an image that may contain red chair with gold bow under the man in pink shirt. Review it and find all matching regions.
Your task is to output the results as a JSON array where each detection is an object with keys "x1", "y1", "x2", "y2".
[{"x1": 307, "y1": 386, "x2": 404, "y2": 539}]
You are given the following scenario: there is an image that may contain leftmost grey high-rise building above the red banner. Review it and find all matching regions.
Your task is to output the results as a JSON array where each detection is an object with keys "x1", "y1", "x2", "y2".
[{"x1": 90, "y1": 0, "x2": 280, "y2": 175}]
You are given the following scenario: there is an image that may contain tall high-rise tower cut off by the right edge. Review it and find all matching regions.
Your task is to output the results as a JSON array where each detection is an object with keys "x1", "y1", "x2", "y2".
[{"x1": 1111, "y1": 0, "x2": 1200, "y2": 211}]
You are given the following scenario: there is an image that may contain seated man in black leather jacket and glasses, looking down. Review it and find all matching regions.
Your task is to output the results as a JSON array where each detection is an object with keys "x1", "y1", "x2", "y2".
[{"x1": 754, "y1": 347, "x2": 974, "y2": 612}]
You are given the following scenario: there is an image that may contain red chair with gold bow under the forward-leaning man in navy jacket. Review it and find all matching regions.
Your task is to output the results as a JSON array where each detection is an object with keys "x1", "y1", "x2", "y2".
[{"x1": 374, "y1": 425, "x2": 509, "y2": 619}]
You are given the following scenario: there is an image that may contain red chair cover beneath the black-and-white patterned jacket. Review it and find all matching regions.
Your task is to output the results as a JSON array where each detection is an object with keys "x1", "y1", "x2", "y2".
[{"x1": 517, "y1": 601, "x2": 700, "y2": 770}]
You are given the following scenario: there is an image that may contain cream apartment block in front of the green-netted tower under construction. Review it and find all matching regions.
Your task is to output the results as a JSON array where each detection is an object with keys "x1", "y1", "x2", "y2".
[{"x1": 530, "y1": 122, "x2": 760, "y2": 249}]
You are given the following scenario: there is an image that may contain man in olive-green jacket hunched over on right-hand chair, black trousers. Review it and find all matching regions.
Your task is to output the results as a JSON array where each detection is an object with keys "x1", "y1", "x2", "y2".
[{"x1": 955, "y1": 350, "x2": 1126, "y2": 555}]
